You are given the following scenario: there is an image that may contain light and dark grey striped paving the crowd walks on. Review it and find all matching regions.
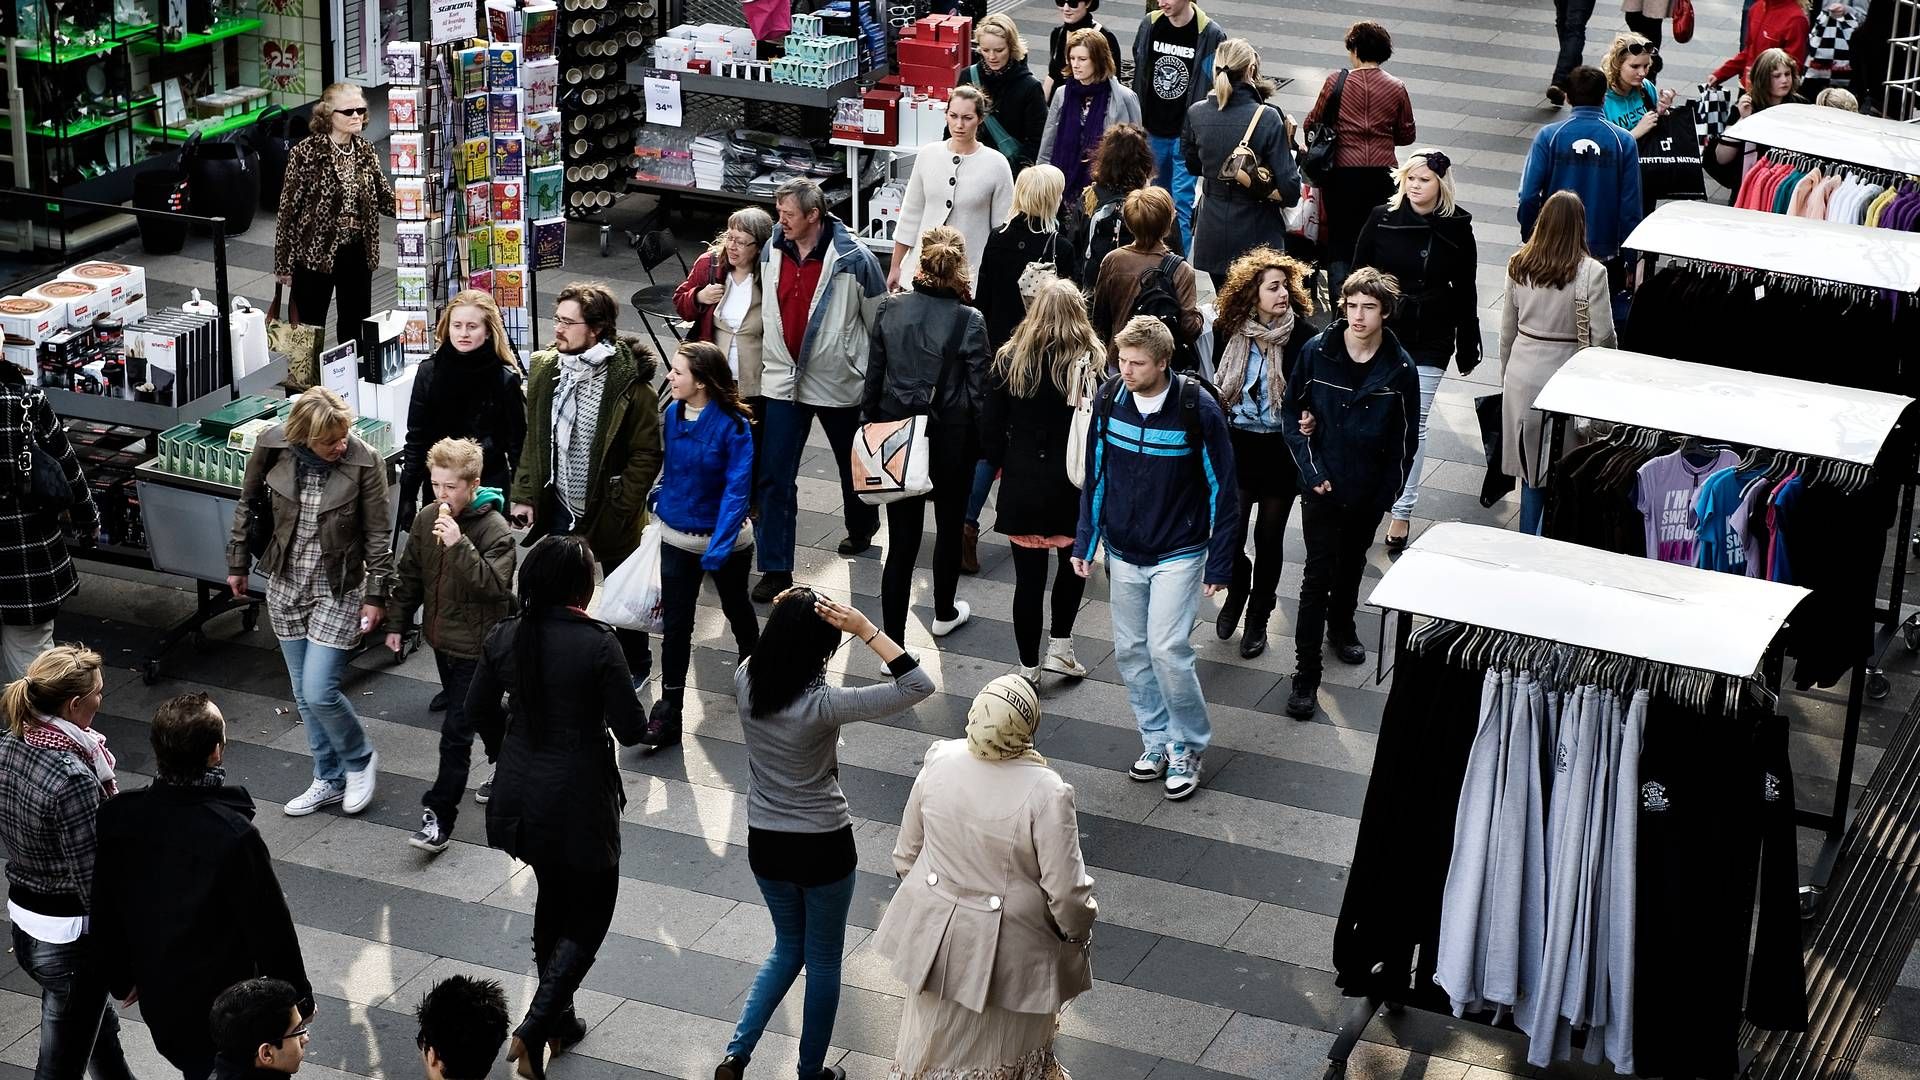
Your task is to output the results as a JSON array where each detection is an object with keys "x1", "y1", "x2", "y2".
[{"x1": 0, "y1": 0, "x2": 1920, "y2": 1080}]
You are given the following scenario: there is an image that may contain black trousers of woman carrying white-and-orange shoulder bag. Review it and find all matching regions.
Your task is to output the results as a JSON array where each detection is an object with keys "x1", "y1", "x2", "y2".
[{"x1": 879, "y1": 429, "x2": 979, "y2": 642}]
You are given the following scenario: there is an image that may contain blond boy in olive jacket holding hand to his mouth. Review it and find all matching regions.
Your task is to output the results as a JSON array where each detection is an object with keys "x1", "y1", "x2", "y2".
[{"x1": 386, "y1": 438, "x2": 515, "y2": 855}]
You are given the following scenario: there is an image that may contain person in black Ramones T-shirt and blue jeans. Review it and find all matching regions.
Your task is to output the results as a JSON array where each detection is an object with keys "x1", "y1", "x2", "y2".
[{"x1": 1133, "y1": 0, "x2": 1227, "y2": 258}]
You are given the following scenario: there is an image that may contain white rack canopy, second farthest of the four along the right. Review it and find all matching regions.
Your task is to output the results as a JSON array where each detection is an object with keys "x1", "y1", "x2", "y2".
[{"x1": 1622, "y1": 199, "x2": 1920, "y2": 292}]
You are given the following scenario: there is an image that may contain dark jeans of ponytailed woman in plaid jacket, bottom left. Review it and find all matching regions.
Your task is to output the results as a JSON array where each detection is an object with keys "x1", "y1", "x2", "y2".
[{"x1": 13, "y1": 926, "x2": 132, "y2": 1080}]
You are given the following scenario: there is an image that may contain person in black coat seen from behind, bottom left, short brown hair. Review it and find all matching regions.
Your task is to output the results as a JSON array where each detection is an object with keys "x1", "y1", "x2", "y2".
[{"x1": 92, "y1": 694, "x2": 313, "y2": 1080}]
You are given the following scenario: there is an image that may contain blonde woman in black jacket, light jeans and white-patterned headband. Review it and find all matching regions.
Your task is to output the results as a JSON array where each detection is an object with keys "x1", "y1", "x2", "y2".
[{"x1": 1354, "y1": 150, "x2": 1480, "y2": 552}]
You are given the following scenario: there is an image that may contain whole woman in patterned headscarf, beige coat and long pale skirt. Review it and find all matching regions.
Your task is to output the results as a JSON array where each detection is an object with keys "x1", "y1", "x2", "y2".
[{"x1": 876, "y1": 675, "x2": 1098, "y2": 1080}]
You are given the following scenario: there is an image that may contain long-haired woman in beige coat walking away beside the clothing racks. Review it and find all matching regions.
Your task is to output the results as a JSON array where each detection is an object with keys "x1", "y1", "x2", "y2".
[{"x1": 1500, "y1": 192, "x2": 1615, "y2": 536}]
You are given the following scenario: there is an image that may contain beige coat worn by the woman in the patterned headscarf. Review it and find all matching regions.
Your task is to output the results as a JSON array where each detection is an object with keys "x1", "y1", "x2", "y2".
[{"x1": 876, "y1": 740, "x2": 1098, "y2": 1013}]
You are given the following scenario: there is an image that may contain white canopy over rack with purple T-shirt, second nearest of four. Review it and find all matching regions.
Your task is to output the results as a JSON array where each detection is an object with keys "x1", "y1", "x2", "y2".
[{"x1": 1534, "y1": 348, "x2": 1912, "y2": 465}]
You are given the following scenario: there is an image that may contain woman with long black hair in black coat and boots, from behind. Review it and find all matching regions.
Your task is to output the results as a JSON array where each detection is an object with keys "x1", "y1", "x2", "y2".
[{"x1": 467, "y1": 536, "x2": 647, "y2": 1080}]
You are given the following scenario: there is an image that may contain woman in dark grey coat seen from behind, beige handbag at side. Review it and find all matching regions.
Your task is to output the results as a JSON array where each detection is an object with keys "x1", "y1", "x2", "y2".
[{"x1": 1181, "y1": 38, "x2": 1300, "y2": 282}]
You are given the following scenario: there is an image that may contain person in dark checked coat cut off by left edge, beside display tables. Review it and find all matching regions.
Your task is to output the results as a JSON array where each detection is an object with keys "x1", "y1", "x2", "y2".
[{"x1": 0, "y1": 363, "x2": 100, "y2": 678}]
